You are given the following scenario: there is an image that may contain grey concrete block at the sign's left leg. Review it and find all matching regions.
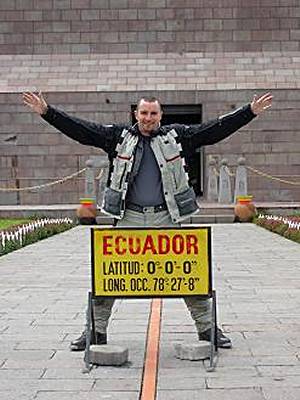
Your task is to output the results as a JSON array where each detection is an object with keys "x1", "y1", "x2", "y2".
[{"x1": 90, "y1": 344, "x2": 128, "y2": 365}]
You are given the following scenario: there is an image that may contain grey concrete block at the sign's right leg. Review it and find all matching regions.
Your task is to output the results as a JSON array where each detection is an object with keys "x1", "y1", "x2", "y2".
[{"x1": 174, "y1": 340, "x2": 210, "y2": 361}]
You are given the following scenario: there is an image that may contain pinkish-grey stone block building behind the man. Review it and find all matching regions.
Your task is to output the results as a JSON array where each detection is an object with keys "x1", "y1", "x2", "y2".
[{"x1": 0, "y1": 0, "x2": 300, "y2": 204}]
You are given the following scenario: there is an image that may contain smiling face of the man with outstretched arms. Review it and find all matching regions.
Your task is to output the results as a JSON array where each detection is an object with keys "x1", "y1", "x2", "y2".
[{"x1": 135, "y1": 99, "x2": 162, "y2": 136}]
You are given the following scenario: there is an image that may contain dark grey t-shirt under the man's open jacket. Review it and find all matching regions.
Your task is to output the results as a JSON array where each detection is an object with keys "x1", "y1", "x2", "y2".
[{"x1": 126, "y1": 136, "x2": 165, "y2": 207}]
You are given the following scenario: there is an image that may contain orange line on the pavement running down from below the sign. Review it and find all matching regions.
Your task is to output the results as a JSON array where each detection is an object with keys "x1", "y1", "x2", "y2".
[{"x1": 140, "y1": 299, "x2": 162, "y2": 400}]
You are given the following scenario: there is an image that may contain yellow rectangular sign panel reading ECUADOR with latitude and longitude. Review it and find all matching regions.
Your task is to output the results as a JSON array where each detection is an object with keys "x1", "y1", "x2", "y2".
[{"x1": 92, "y1": 227, "x2": 212, "y2": 297}]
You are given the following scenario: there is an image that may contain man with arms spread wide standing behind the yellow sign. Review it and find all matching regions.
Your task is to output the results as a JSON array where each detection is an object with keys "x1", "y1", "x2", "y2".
[{"x1": 23, "y1": 92, "x2": 272, "y2": 351}]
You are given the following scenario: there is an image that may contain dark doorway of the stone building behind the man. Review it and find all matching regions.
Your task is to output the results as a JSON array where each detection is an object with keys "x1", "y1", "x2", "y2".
[{"x1": 131, "y1": 104, "x2": 204, "y2": 196}]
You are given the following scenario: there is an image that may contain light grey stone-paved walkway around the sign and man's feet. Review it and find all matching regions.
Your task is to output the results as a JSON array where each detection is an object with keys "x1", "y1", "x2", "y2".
[{"x1": 0, "y1": 224, "x2": 300, "y2": 400}]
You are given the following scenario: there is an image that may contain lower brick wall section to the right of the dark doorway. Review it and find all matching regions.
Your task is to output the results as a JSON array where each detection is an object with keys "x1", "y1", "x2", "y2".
[{"x1": 204, "y1": 90, "x2": 300, "y2": 202}]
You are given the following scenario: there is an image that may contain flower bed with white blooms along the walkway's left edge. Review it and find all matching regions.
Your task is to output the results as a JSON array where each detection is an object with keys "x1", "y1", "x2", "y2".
[{"x1": 0, "y1": 218, "x2": 75, "y2": 256}]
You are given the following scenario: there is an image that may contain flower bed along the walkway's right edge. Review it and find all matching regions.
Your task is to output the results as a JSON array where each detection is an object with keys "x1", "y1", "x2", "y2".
[{"x1": 255, "y1": 214, "x2": 300, "y2": 243}]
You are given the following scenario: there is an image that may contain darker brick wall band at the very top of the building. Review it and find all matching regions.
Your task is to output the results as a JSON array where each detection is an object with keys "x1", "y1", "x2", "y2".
[{"x1": 0, "y1": 0, "x2": 300, "y2": 54}]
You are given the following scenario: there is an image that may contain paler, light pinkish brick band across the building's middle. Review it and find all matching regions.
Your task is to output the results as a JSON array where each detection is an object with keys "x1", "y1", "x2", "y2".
[{"x1": 0, "y1": 51, "x2": 300, "y2": 92}]
